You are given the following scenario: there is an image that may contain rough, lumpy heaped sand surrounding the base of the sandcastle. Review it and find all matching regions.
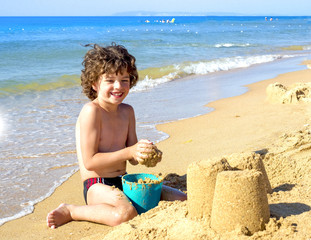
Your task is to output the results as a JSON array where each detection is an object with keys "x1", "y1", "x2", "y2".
[{"x1": 87, "y1": 125, "x2": 311, "y2": 240}]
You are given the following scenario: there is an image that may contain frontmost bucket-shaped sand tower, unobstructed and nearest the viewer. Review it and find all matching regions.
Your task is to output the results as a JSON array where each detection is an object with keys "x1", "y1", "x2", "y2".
[{"x1": 211, "y1": 170, "x2": 270, "y2": 234}]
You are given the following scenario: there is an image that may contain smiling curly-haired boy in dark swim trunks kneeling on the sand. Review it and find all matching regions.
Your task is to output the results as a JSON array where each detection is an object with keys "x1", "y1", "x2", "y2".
[{"x1": 47, "y1": 44, "x2": 186, "y2": 228}]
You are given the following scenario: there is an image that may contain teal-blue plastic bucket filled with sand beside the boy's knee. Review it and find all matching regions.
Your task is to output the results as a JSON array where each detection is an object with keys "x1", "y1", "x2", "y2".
[{"x1": 122, "y1": 173, "x2": 163, "y2": 214}]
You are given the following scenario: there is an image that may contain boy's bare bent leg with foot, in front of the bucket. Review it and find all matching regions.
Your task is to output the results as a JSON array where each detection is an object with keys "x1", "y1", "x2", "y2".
[{"x1": 47, "y1": 183, "x2": 137, "y2": 228}]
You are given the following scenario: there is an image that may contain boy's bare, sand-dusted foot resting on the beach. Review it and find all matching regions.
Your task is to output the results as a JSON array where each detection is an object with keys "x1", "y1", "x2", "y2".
[{"x1": 46, "y1": 203, "x2": 72, "y2": 229}]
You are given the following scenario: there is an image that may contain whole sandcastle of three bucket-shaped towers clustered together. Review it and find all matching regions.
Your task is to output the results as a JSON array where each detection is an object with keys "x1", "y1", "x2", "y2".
[{"x1": 187, "y1": 153, "x2": 272, "y2": 234}]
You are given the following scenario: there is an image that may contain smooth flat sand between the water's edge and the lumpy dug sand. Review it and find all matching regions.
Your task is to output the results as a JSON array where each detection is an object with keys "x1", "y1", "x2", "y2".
[{"x1": 0, "y1": 62, "x2": 311, "y2": 239}]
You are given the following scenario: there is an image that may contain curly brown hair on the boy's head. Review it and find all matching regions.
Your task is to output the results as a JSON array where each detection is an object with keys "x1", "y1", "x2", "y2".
[{"x1": 81, "y1": 43, "x2": 138, "y2": 100}]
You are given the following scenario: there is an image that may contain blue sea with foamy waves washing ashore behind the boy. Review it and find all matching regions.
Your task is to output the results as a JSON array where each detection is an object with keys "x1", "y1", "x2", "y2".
[{"x1": 0, "y1": 16, "x2": 311, "y2": 225}]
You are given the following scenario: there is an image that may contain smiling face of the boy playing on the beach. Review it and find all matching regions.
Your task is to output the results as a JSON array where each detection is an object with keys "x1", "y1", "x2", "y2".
[{"x1": 93, "y1": 71, "x2": 130, "y2": 104}]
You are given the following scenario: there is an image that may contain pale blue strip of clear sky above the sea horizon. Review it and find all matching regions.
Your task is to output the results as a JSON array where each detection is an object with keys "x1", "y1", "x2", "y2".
[{"x1": 0, "y1": 0, "x2": 311, "y2": 16}]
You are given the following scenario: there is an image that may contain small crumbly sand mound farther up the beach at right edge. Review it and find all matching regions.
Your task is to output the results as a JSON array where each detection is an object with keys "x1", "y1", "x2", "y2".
[{"x1": 266, "y1": 82, "x2": 311, "y2": 104}]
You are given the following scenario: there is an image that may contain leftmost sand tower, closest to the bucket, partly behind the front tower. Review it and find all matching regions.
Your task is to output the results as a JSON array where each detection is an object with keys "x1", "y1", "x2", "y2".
[{"x1": 187, "y1": 160, "x2": 231, "y2": 220}]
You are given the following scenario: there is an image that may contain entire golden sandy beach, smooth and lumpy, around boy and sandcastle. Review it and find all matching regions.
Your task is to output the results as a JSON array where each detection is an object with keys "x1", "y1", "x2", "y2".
[{"x1": 0, "y1": 61, "x2": 311, "y2": 240}]
